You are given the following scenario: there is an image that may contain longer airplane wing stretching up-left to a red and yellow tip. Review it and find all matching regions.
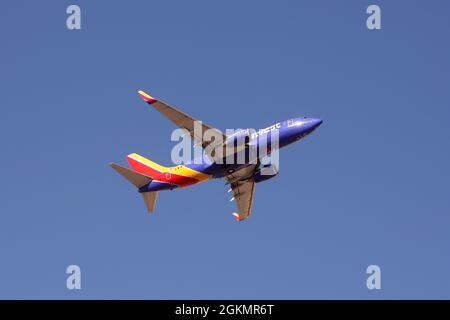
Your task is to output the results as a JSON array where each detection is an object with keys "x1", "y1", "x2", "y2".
[{"x1": 139, "y1": 90, "x2": 226, "y2": 148}]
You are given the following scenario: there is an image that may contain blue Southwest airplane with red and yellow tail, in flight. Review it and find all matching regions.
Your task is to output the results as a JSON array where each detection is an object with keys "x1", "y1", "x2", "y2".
[{"x1": 110, "y1": 90, "x2": 322, "y2": 221}]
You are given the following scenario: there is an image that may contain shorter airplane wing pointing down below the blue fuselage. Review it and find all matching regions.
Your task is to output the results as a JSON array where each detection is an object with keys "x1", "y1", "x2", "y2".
[{"x1": 225, "y1": 165, "x2": 256, "y2": 221}]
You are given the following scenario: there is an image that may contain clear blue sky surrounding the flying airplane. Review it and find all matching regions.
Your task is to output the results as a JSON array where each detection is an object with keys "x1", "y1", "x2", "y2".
[{"x1": 0, "y1": 0, "x2": 450, "y2": 299}]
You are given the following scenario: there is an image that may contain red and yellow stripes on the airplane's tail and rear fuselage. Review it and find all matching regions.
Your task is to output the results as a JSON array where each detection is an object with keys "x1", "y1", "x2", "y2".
[{"x1": 127, "y1": 153, "x2": 209, "y2": 187}]
